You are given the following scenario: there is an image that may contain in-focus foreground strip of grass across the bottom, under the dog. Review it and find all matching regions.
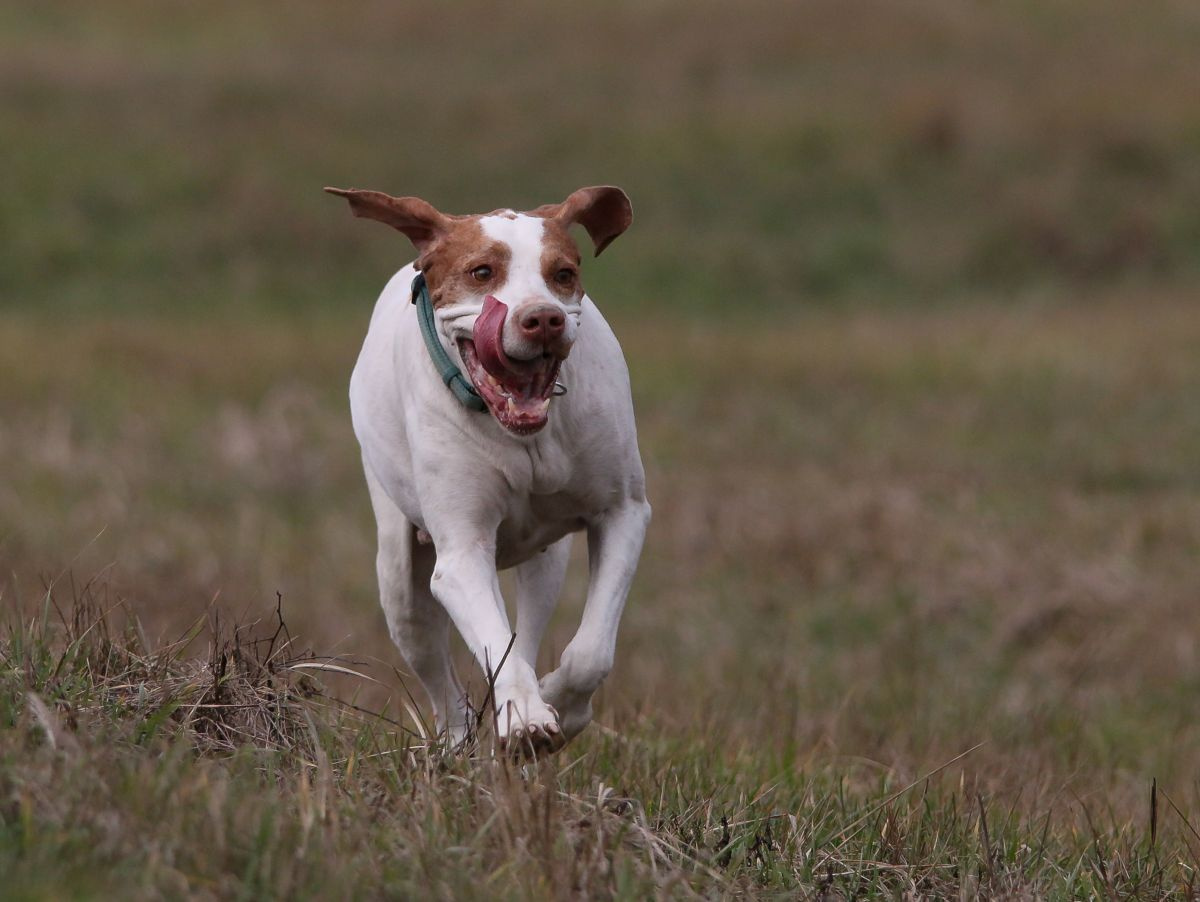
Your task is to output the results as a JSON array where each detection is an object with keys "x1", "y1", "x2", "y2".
[{"x1": 0, "y1": 590, "x2": 1194, "y2": 898}]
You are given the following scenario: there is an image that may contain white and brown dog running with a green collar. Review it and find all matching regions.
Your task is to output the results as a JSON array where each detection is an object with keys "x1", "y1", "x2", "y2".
[{"x1": 326, "y1": 186, "x2": 650, "y2": 756}]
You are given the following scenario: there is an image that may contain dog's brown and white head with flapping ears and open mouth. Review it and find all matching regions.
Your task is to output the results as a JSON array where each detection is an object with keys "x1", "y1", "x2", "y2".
[{"x1": 326, "y1": 187, "x2": 632, "y2": 435}]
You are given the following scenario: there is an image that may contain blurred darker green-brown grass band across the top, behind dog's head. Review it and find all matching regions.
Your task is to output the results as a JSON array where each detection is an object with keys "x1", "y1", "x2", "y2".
[{"x1": 0, "y1": 0, "x2": 1200, "y2": 313}]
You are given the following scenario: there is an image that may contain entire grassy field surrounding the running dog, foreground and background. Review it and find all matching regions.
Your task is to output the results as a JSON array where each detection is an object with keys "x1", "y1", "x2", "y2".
[{"x1": 0, "y1": 2, "x2": 1200, "y2": 898}]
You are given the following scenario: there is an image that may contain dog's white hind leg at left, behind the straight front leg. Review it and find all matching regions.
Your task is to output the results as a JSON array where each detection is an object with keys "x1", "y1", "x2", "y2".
[{"x1": 364, "y1": 462, "x2": 470, "y2": 745}]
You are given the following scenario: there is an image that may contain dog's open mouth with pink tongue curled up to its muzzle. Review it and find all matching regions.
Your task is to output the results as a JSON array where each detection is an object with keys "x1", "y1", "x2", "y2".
[{"x1": 458, "y1": 296, "x2": 563, "y2": 435}]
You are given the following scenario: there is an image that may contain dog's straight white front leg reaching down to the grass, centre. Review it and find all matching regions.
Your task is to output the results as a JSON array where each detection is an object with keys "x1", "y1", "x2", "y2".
[{"x1": 430, "y1": 536, "x2": 565, "y2": 752}]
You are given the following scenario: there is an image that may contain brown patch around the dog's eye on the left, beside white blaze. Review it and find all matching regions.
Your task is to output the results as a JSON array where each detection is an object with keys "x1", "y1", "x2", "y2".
[{"x1": 416, "y1": 216, "x2": 512, "y2": 307}]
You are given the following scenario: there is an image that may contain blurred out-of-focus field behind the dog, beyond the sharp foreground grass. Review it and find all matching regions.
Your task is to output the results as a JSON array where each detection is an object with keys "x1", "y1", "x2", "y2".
[{"x1": 0, "y1": 0, "x2": 1200, "y2": 810}]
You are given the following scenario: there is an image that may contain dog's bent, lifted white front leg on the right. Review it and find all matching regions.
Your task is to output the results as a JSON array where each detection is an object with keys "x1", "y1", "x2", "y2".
[{"x1": 541, "y1": 499, "x2": 650, "y2": 739}]
